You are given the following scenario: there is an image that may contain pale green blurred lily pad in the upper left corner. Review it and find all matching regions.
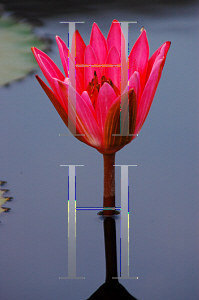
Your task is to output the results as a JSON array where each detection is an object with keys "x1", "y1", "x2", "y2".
[{"x1": 0, "y1": 17, "x2": 49, "y2": 86}]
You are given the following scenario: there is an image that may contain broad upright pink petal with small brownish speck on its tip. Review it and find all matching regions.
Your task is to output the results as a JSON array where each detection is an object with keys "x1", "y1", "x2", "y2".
[{"x1": 129, "y1": 30, "x2": 149, "y2": 91}]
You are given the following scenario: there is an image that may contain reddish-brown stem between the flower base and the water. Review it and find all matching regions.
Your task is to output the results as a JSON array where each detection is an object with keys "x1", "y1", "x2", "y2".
[{"x1": 103, "y1": 153, "x2": 115, "y2": 215}]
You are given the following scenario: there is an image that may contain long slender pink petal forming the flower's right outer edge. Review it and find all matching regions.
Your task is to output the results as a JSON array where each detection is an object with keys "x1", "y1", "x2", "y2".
[{"x1": 135, "y1": 58, "x2": 165, "y2": 134}]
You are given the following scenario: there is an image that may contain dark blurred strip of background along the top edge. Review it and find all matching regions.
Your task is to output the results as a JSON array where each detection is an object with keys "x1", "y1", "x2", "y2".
[{"x1": 1, "y1": 0, "x2": 198, "y2": 17}]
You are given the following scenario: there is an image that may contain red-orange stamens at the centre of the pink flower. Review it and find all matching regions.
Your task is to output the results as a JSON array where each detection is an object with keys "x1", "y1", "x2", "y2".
[{"x1": 86, "y1": 71, "x2": 120, "y2": 108}]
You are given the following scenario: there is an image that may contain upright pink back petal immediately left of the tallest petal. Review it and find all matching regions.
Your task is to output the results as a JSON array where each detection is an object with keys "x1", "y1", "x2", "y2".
[{"x1": 90, "y1": 23, "x2": 107, "y2": 64}]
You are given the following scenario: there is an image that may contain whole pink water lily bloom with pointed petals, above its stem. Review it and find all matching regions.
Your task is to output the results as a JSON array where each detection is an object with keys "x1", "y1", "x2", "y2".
[{"x1": 32, "y1": 20, "x2": 170, "y2": 154}]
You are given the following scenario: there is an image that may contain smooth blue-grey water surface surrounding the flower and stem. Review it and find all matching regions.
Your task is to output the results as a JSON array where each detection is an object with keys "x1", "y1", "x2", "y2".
[{"x1": 0, "y1": 7, "x2": 199, "y2": 300}]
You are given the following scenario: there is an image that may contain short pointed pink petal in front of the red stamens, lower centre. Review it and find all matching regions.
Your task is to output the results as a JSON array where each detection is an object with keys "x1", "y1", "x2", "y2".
[{"x1": 96, "y1": 82, "x2": 117, "y2": 135}]
